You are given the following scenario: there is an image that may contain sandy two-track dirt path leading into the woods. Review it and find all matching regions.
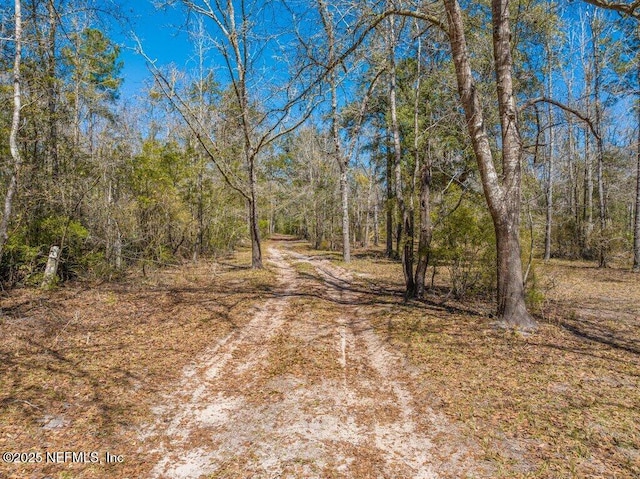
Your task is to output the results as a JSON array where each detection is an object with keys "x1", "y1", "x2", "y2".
[{"x1": 143, "y1": 248, "x2": 476, "y2": 479}]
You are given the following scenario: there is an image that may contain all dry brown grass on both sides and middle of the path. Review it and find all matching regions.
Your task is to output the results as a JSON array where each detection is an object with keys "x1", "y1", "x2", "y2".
[{"x1": 0, "y1": 243, "x2": 640, "y2": 479}]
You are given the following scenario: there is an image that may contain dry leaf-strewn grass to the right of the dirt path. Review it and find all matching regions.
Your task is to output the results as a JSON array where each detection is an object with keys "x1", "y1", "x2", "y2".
[{"x1": 336, "y1": 248, "x2": 640, "y2": 478}]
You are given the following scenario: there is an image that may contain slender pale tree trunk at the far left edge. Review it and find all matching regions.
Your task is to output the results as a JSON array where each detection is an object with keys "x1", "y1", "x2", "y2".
[{"x1": 0, "y1": 0, "x2": 22, "y2": 261}]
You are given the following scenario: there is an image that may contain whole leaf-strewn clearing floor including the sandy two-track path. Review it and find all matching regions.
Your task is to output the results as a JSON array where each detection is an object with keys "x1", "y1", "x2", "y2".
[{"x1": 0, "y1": 238, "x2": 640, "y2": 479}]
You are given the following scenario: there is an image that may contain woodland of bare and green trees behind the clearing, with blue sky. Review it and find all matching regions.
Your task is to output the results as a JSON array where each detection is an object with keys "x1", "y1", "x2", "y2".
[{"x1": 0, "y1": 1, "x2": 640, "y2": 329}]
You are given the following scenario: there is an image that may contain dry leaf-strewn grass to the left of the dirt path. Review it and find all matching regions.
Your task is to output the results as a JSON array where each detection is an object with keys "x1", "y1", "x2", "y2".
[{"x1": 0, "y1": 251, "x2": 273, "y2": 479}]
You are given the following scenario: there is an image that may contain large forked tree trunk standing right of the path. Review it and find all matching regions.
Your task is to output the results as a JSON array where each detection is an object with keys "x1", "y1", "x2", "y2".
[{"x1": 444, "y1": 0, "x2": 536, "y2": 330}]
